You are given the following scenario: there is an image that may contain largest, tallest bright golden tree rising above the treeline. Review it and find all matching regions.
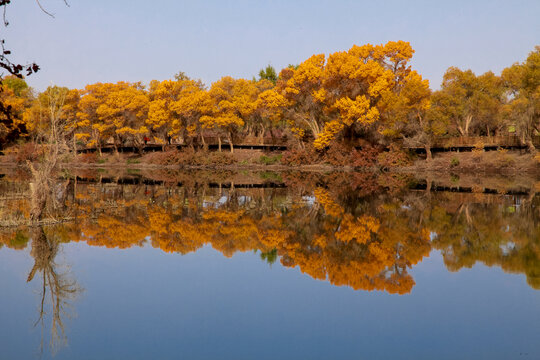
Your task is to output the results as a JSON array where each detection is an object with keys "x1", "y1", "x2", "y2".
[{"x1": 278, "y1": 41, "x2": 427, "y2": 150}]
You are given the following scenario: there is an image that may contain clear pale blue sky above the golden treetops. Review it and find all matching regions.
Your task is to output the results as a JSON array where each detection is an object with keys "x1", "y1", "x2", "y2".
[{"x1": 0, "y1": 0, "x2": 540, "y2": 91}]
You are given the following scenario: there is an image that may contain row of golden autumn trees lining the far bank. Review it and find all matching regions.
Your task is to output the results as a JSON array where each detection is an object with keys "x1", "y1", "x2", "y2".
[{"x1": 0, "y1": 41, "x2": 540, "y2": 157}]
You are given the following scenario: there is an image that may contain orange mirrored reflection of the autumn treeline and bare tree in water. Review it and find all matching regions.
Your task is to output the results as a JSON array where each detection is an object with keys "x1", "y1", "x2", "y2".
[{"x1": 0, "y1": 171, "x2": 540, "y2": 354}]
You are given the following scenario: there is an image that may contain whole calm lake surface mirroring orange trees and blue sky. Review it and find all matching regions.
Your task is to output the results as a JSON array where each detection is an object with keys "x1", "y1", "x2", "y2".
[{"x1": 0, "y1": 170, "x2": 540, "y2": 359}]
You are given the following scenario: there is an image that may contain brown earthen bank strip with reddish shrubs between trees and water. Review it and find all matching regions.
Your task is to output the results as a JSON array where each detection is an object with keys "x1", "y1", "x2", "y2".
[{"x1": 0, "y1": 149, "x2": 540, "y2": 175}]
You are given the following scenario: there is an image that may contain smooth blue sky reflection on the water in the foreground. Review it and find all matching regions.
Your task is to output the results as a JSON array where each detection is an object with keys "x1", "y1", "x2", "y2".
[{"x1": 0, "y1": 243, "x2": 540, "y2": 359}]
